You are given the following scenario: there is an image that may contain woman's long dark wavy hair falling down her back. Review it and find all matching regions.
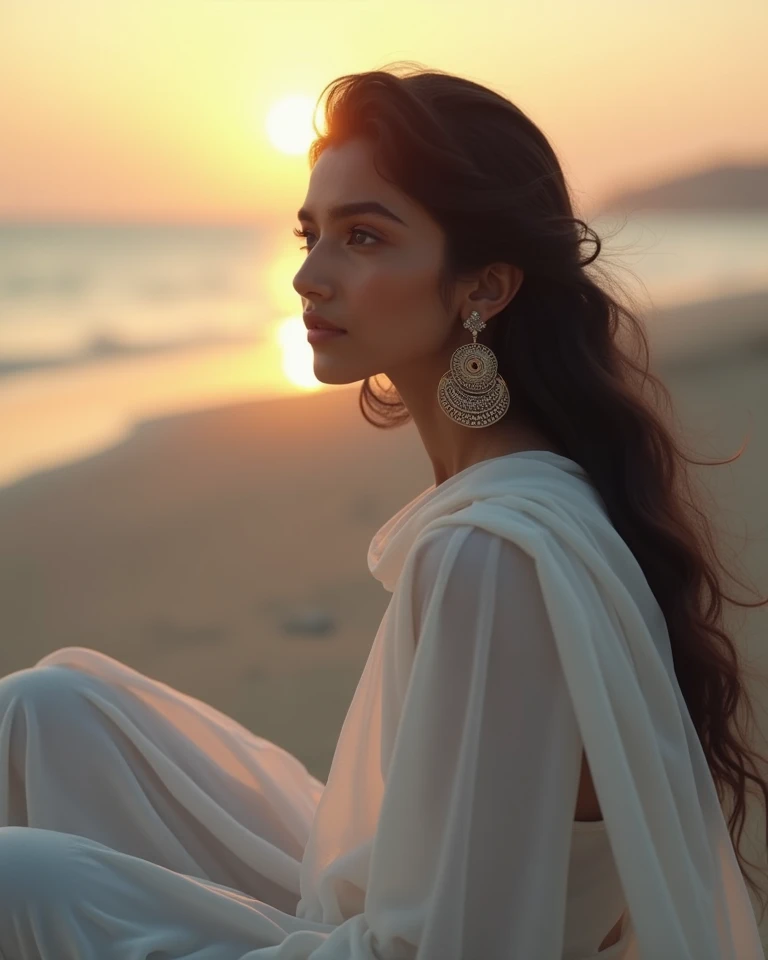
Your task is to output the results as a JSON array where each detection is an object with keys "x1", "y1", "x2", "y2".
[{"x1": 309, "y1": 61, "x2": 768, "y2": 912}]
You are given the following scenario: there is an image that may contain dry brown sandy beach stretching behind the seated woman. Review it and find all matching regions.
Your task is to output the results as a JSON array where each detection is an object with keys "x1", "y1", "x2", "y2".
[{"x1": 0, "y1": 295, "x2": 768, "y2": 926}]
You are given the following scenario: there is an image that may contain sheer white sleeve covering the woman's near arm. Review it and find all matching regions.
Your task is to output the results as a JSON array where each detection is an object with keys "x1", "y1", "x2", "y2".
[{"x1": 284, "y1": 525, "x2": 582, "y2": 960}]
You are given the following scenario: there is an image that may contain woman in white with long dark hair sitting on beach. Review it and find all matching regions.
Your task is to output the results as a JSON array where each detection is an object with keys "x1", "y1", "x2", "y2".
[{"x1": 0, "y1": 63, "x2": 768, "y2": 960}]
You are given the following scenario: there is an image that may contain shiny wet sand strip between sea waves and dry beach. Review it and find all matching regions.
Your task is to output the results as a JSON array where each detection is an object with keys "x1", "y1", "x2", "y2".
[{"x1": 0, "y1": 289, "x2": 768, "y2": 496}]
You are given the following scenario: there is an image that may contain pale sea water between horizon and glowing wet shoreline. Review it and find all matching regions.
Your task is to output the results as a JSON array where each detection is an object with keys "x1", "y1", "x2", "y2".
[{"x1": 0, "y1": 213, "x2": 768, "y2": 377}]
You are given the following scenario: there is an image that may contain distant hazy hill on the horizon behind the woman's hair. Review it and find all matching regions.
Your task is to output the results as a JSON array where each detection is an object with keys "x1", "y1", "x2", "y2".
[{"x1": 600, "y1": 163, "x2": 768, "y2": 214}]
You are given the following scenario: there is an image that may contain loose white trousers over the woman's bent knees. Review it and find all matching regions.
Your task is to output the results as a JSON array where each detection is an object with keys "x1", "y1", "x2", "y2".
[{"x1": 0, "y1": 647, "x2": 329, "y2": 960}]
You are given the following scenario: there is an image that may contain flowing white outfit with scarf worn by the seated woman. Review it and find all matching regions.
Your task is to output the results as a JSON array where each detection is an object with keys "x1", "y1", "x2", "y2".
[{"x1": 0, "y1": 451, "x2": 764, "y2": 960}]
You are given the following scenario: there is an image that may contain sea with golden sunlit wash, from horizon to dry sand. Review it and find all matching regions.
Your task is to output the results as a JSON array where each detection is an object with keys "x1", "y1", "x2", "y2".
[{"x1": 0, "y1": 212, "x2": 768, "y2": 492}]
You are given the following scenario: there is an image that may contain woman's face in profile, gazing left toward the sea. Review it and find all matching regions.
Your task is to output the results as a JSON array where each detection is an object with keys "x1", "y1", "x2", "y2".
[{"x1": 293, "y1": 139, "x2": 460, "y2": 384}]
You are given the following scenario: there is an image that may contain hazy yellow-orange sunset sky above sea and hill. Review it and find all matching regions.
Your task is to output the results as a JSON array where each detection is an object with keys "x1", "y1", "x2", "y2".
[{"x1": 0, "y1": 0, "x2": 768, "y2": 222}]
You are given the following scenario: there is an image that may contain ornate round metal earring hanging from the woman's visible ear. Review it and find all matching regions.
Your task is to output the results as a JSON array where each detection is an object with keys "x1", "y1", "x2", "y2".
[{"x1": 437, "y1": 310, "x2": 509, "y2": 427}]
